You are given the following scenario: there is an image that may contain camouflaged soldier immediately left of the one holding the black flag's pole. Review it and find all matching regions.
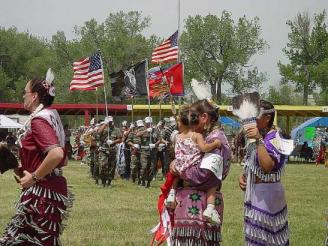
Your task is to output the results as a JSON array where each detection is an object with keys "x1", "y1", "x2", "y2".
[{"x1": 127, "y1": 120, "x2": 143, "y2": 184}]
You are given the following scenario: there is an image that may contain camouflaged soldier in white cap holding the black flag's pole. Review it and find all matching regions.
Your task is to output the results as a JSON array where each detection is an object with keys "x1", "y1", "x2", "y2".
[{"x1": 136, "y1": 117, "x2": 159, "y2": 188}]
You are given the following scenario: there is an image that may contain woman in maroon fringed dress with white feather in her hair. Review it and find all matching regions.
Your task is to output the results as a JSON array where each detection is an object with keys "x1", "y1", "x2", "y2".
[{"x1": 0, "y1": 69, "x2": 72, "y2": 245}]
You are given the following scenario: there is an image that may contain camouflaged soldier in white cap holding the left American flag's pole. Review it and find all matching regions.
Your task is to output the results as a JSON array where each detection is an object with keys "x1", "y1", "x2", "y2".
[{"x1": 98, "y1": 116, "x2": 122, "y2": 187}]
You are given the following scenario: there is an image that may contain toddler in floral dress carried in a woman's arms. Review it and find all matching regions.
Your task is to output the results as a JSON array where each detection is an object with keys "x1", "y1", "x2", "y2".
[{"x1": 166, "y1": 107, "x2": 221, "y2": 224}]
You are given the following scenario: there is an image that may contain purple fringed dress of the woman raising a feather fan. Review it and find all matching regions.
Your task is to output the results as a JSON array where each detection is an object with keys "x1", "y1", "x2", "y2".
[{"x1": 244, "y1": 131, "x2": 289, "y2": 246}]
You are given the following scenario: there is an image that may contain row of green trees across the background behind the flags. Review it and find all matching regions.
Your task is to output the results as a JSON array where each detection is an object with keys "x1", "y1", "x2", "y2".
[{"x1": 0, "y1": 10, "x2": 328, "y2": 105}]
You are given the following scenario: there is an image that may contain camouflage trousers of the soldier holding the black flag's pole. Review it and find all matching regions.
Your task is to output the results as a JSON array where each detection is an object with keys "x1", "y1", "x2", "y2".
[{"x1": 140, "y1": 149, "x2": 156, "y2": 182}]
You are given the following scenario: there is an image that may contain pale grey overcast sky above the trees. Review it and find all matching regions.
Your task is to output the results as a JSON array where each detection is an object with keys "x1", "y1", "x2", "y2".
[{"x1": 0, "y1": 0, "x2": 328, "y2": 93}]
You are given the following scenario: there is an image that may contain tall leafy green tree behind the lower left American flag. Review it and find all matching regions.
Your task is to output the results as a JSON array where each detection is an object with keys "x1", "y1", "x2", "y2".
[{"x1": 52, "y1": 11, "x2": 159, "y2": 102}]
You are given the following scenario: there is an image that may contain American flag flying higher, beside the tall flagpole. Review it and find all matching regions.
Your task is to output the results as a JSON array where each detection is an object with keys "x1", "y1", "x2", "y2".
[{"x1": 151, "y1": 31, "x2": 179, "y2": 63}]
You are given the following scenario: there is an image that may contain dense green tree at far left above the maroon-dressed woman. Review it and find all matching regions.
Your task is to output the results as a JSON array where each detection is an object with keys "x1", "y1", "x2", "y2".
[{"x1": 0, "y1": 27, "x2": 53, "y2": 102}]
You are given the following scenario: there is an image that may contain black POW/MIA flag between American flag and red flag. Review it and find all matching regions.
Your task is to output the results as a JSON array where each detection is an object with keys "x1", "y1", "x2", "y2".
[{"x1": 110, "y1": 61, "x2": 148, "y2": 98}]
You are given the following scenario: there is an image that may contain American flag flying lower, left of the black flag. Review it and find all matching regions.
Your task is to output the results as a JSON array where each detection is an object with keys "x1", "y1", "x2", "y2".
[{"x1": 69, "y1": 53, "x2": 104, "y2": 91}]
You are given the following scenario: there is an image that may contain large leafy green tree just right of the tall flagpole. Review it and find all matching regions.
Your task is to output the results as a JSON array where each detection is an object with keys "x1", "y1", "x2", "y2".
[{"x1": 181, "y1": 11, "x2": 267, "y2": 102}]
